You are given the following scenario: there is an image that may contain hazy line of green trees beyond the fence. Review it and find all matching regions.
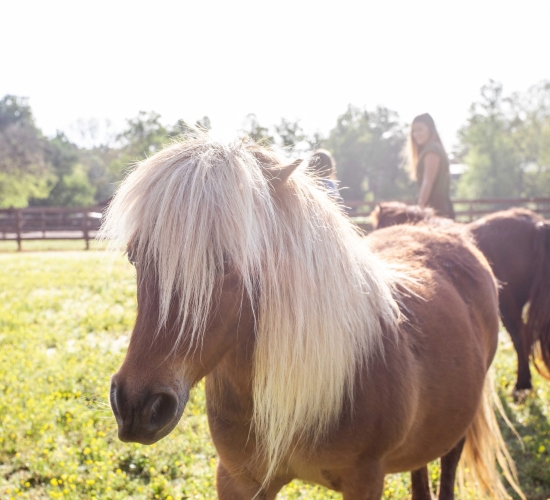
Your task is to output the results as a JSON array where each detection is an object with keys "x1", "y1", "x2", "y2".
[{"x1": 0, "y1": 81, "x2": 550, "y2": 208}]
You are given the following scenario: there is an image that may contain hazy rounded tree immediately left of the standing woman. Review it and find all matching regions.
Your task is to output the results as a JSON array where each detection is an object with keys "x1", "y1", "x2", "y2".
[{"x1": 321, "y1": 104, "x2": 414, "y2": 201}]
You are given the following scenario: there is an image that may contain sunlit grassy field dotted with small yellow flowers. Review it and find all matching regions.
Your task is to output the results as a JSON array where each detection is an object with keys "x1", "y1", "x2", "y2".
[{"x1": 0, "y1": 250, "x2": 550, "y2": 500}]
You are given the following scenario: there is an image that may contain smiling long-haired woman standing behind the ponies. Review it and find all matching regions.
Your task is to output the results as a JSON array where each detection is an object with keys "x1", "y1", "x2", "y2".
[{"x1": 408, "y1": 113, "x2": 455, "y2": 219}]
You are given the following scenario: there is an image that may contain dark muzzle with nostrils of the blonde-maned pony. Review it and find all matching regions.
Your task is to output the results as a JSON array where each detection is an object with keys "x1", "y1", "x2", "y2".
[{"x1": 109, "y1": 375, "x2": 187, "y2": 444}]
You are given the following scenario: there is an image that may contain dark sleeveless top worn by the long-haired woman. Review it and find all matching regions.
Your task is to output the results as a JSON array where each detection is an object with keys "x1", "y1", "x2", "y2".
[{"x1": 416, "y1": 142, "x2": 455, "y2": 219}]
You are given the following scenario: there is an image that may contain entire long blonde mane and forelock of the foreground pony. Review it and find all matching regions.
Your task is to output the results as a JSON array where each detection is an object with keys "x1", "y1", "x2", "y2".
[{"x1": 101, "y1": 132, "x2": 399, "y2": 481}]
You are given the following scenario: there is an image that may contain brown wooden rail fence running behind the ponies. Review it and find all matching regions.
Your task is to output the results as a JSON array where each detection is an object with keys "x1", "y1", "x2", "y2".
[{"x1": 0, "y1": 198, "x2": 550, "y2": 250}]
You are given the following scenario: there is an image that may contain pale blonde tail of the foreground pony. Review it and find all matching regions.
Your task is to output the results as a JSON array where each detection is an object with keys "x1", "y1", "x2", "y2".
[{"x1": 459, "y1": 371, "x2": 525, "y2": 500}]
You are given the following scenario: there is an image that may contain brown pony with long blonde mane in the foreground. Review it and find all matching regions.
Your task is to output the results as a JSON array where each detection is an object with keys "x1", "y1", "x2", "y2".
[{"x1": 101, "y1": 135, "x2": 520, "y2": 500}]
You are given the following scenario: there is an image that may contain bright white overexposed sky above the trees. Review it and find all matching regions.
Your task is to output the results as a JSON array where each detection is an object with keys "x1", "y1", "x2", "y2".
[{"x1": 0, "y1": 0, "x2": 550, "y2": 148}]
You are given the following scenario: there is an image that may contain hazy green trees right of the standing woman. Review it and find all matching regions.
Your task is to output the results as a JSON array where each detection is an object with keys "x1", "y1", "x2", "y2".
[{"x1": 458, "y1": 80, "x2": 550, "y2": 198}]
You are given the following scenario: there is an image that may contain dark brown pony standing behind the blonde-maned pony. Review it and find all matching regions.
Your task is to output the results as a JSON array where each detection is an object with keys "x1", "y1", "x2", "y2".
[{"x1": 371, "y1": 202, "x2": 550, "y2": 396}]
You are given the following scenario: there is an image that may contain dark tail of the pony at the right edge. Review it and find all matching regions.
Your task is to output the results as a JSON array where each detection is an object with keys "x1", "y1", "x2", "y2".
[{"x1": 523, "y1": 222, "x2": 550, "y2": 378}]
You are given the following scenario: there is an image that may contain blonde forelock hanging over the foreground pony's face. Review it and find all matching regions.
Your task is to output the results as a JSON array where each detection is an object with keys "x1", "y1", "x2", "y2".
[{"x1": 100, "y1": 136, "x2": 269, "y2": 347}]
